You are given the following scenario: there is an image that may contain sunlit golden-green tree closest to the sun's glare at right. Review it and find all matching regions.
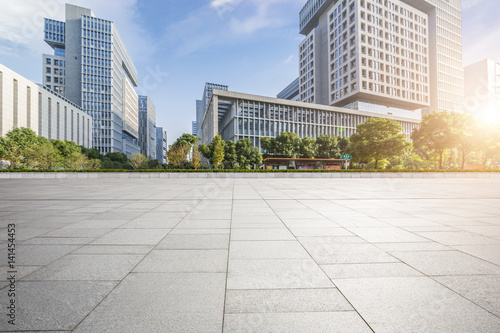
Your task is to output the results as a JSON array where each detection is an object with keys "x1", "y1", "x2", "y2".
[{"x1": 411, "y1": 111, "x2": 460, "y2": 169}]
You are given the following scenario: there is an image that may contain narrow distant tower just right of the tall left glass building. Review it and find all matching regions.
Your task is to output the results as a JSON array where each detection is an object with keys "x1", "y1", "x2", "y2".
[{"x1": 139, "y1": 96, "x2": 156, "y2": 159}]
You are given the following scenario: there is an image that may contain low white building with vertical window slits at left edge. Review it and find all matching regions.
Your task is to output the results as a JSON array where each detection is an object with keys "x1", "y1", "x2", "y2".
[{"x1": 0, "y1": 64, "x2": 92, "y2": 148}]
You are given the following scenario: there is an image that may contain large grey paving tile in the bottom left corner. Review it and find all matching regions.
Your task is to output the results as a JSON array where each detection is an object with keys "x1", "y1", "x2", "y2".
[{"x1": 0, "y1": 281, "x2": 116, "y2": 332}]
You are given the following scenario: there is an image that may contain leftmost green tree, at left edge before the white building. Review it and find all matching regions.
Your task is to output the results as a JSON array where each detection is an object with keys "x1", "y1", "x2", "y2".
[{"x1": 0, "y1": 128, "x2": 40, "y2": 169}]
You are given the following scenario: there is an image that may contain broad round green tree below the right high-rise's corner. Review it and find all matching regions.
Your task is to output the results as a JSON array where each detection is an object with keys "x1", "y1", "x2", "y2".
[{"x1": 348, "y1": 118, "x2": 412, "y2": 169}]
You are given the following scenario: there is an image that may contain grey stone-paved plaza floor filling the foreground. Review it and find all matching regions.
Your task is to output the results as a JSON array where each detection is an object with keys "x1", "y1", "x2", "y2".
[{"x1": 0, "y1": 178, "x2": 500, "y2": 333}]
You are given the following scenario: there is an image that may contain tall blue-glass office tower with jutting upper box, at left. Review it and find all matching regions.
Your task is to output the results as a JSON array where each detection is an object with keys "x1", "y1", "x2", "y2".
[{"x1": 43, "y1": 4, "x2": 140, "y2": 156}]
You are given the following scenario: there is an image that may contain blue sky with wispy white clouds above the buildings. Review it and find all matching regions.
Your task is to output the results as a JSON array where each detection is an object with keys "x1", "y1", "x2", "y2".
[{"x1": 0, "y1": 0, "x2": 500, "y2": 143}]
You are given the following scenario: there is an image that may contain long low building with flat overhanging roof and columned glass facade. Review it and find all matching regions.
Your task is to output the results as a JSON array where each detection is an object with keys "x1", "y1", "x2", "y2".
[{"x1": 202, "y1": 90, "x2": 420, "y2": 148}]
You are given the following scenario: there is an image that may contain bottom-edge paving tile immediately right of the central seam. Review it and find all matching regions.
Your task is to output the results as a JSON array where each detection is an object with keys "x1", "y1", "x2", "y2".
[{"x1": 224, "y1": 311, "x2": 372, "y2": 333}]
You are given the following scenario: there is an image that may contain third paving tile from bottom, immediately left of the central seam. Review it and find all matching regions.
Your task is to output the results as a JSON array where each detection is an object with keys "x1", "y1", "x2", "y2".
[{"x1": 157, "y1": 235, "x2": 229, "y2": 250}]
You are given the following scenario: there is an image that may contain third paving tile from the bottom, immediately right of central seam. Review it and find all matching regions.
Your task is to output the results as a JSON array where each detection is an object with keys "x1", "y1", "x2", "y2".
[{"x1": 227, "y1": 259, "x2": 333, "y2": 289}]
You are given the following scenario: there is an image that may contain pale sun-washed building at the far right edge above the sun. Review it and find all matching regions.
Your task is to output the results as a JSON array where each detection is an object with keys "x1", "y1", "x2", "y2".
[{"x1": 464, "y1": 59, "x2": 500, "y2": 124}]
